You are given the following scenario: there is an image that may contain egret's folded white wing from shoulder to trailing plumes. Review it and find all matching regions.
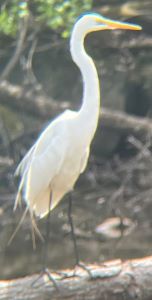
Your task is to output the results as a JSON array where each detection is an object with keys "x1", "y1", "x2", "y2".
[{"x1": 14, "y1": 110, "x2": 76, "y2": 210}]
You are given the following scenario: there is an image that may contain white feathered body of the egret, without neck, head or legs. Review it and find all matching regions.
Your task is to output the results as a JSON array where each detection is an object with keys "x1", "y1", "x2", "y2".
[{"x1": 17, "y1": 111, "x2": 89, "y2": 217}]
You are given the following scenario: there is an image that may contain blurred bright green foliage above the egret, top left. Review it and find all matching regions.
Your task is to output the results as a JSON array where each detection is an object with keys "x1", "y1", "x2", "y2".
[{"x1": 0, "y1": 0, "x2": 93, "y2": 37}]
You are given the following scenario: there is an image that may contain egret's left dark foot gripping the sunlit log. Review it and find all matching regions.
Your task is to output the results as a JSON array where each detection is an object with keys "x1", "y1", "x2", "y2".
[{"x1": 32, "y1": 268, "x2": 59, "y2": 291}]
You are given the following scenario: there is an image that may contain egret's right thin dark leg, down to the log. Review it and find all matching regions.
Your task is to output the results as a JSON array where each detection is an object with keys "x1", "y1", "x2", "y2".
[{"x1": 68, "y1": 194, "x2": 92, "y2": 277}]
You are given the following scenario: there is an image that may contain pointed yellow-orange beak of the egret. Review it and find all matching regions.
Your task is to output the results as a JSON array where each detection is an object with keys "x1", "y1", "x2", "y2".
[{"x1": 97, "y1": 17, "x2": 142, "y2": 30}]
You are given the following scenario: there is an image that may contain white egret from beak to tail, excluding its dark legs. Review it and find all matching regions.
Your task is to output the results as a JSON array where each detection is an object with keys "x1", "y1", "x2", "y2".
[{"x1": 15, "y1": 13, "x2": 141, "y2": 218}]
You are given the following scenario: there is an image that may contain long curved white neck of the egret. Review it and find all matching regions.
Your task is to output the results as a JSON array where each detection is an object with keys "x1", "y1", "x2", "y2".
[{"x1": 70, "y1": 26, "x2": 100, "y2": 139}]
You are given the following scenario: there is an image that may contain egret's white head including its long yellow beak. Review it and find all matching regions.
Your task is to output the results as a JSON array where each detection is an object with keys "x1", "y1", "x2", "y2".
[{"x1": 77, "y1": 13, "x2": 142, "y2": 33}]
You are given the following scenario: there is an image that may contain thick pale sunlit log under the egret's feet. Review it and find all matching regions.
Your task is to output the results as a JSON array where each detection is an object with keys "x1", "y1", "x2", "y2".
[{"x1": 0, "y1": 257, "x2": 152, "y2": 300}]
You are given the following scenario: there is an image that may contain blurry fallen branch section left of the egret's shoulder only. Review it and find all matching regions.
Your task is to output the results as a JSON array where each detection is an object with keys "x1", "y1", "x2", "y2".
[{"x1": 0, "y1": 81, "x2": 68, "y2": 120}]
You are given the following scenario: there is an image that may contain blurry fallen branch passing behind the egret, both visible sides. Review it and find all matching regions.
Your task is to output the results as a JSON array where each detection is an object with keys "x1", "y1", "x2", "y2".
[{"x1": 0, "y1": 81, "x2": 152, "y2": 141}]
